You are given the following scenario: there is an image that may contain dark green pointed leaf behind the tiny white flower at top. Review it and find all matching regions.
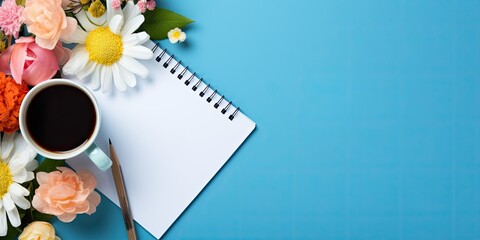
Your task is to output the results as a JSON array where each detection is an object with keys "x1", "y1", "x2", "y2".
[{"x1": 139, "y1": 8, "x2": 194, "y2": 40}]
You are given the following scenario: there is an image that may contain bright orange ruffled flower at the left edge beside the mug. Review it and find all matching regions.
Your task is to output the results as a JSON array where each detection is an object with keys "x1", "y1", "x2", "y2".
[{"x1": 0, "y1": 72, "x2": 28, "y2": 133}]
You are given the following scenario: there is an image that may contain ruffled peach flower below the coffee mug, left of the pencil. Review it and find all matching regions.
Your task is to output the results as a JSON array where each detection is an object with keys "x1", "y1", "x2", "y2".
[{"x1": 32, "y1": 167, "x2": 100, "y2": 222}]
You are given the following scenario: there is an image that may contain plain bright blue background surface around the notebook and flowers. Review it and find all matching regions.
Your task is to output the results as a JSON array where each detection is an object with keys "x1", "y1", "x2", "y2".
[{"x1": 55, "y1": 0, "x2": 480, "y2": 240}]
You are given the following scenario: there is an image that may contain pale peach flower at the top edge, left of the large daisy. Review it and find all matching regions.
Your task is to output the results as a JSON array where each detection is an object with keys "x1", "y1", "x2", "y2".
[{"x1": 22, "y1": 0, "x2": 77, "y2": 50}]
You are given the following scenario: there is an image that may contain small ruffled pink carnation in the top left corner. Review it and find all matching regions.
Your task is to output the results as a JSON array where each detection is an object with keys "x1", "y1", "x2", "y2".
[{"x1": 0, "y1": 0, "x2": 25, "y2": 38}]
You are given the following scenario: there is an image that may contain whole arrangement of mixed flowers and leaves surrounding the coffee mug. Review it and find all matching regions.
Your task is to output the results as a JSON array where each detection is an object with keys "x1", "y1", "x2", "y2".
[{"x1": 0, "y1": 0, "x2": 193, "y2": 239}]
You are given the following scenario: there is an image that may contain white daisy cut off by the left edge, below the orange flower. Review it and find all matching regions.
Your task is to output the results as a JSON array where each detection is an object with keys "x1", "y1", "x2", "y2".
[{"x1": 0, "y1": 133, "x2": 38, "y2": 236}]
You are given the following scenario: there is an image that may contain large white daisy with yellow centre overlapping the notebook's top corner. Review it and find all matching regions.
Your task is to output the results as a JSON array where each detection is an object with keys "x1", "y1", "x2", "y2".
[{"x1": 63, "y1": 0, "x2": 153, "y2": 93}]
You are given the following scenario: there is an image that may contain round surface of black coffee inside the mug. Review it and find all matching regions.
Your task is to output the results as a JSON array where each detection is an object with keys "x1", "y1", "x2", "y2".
[{"x1": 26, "y1": 85, "x2": 97, "y2": 152}]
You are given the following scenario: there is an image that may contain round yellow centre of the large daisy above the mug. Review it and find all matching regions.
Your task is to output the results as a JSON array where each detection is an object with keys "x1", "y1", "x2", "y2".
[{"x1": 86, "y1": 27, "x2": 123, "y2": 65}]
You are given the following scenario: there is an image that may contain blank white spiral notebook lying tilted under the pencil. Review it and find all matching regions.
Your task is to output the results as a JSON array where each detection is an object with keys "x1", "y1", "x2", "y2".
[{"x1": 67, "y1": 42, "x2": 255, "y2": 238}]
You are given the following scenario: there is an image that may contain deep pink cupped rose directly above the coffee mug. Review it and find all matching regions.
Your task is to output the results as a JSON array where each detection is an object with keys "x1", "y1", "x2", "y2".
[{"x1": 0, "y1": 37, "x2": 70, "y2": 86}]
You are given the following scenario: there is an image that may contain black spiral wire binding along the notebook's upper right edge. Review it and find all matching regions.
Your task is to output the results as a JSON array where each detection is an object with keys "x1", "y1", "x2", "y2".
[{"x1": 151, "y1": 44, "x2": 240, "y2": 121}]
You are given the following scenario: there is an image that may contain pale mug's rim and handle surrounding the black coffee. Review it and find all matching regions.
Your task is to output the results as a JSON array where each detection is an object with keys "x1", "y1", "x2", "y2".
[{"x1": 19, "y1": 79, "x2": 112, "y2": 171}]
